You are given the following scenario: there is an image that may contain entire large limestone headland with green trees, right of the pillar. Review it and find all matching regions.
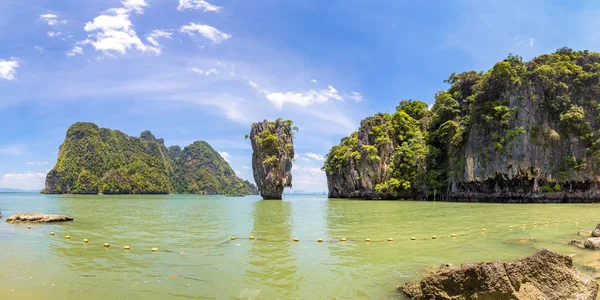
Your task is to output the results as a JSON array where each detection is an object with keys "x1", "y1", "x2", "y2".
[{"x1": 324, "y1": 48, "x2": 600, "y2": 203}]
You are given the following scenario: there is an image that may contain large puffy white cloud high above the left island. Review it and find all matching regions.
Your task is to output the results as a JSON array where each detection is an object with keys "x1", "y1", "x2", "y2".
[{"x1": 83, "y1": 7, "x2": 160, "y2": 55}]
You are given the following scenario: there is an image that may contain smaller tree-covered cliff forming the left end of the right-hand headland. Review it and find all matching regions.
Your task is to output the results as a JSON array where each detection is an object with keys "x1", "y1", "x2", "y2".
[{"x1": 323, "y1": 101, "x2": 430, "y2": 199}]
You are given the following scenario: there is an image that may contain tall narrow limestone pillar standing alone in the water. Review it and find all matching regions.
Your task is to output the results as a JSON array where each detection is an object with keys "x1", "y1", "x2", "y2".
[{"x1": 250, "y1": 119, "x2": 298, "y2": 199}]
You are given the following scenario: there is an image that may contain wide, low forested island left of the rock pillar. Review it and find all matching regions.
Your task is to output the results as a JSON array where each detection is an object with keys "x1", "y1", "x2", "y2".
[{"x1": 42, "y1": 123, "x2": 255, "y2": 194}]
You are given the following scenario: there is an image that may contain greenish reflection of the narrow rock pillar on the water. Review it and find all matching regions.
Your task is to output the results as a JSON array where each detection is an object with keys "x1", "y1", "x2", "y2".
[{"x1": 240, "y1": 201, "x2": 299, "y2": 298}]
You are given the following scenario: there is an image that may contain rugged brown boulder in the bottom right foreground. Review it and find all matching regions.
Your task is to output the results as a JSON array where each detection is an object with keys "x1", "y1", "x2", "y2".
[{"x1": 402, "y1": 249, "x2": 598, "y2": 300}]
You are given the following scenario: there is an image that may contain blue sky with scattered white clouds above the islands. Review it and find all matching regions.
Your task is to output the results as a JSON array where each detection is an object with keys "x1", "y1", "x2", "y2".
[{"x1": 0, "y1": 0, "x2": 600, "y2": 192}]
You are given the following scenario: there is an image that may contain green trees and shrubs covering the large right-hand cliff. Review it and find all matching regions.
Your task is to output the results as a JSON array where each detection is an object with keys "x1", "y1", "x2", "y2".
[{"x1": 323, "y1": 48, "x2": 600, "y2": 197}]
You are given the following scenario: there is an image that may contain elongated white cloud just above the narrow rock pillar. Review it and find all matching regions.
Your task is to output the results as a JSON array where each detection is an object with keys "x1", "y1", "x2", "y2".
[{"x1": 248, "y1": 81, "x2": 343, "y2": 110}]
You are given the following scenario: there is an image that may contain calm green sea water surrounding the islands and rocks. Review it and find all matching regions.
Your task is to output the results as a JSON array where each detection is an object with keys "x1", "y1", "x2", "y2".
[{"x1": 0, "y1": 194, "x2": 600, "y2": 299}]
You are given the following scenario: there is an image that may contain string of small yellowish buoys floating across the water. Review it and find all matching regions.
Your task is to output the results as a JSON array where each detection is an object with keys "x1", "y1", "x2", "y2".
[{"x1": 11, "y1": 218, "x2": 598, "y2": 251}]
